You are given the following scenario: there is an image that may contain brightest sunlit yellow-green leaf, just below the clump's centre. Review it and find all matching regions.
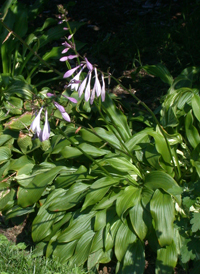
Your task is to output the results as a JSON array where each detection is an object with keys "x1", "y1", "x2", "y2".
[{"x1": 116, "y1": 186, "x2": 141, "y2": 218}]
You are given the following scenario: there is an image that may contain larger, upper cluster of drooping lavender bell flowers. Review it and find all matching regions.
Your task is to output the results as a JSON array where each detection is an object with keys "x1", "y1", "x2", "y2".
[{"x1": 60, "y1": 42, "x2": 105, "y2": 104}]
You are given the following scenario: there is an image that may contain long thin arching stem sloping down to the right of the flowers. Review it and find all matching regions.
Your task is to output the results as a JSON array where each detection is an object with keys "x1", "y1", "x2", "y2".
[{"x1": 111, "y1": 76, "x2": 181, "y2": 181}]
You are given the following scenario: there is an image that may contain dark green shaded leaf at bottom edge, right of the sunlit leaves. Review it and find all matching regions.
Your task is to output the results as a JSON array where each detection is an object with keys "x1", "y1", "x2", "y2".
[{"x1": 122, "y1": 240, "x2": 145, "y2": 274}]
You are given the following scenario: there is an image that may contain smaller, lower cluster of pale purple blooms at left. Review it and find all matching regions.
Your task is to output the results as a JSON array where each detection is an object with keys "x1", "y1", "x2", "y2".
[{"x1": 30, "y1": 93, "x2": 77, "y2": 142}]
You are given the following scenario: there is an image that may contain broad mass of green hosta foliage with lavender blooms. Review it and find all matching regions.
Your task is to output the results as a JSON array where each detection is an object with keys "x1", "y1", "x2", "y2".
[{"x1": 0, "y1": 13, "x2": 200, "y2": 274}]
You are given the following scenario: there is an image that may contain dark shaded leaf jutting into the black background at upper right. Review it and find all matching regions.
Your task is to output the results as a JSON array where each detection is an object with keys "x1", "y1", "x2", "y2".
[{"x1": 142, "y1": 64, "x2": 173, "y2": 86}]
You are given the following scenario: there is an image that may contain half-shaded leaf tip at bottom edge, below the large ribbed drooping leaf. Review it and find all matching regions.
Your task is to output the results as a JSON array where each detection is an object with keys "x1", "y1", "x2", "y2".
[{"x1": 155, "y1": 242, "x2": 178, "y2": 274}]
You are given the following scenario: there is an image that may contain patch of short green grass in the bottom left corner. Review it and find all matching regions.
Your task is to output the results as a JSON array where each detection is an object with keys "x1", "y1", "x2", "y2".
[{"x1": 0, "y1": 234, "x2": 91, "y2": 274}]
